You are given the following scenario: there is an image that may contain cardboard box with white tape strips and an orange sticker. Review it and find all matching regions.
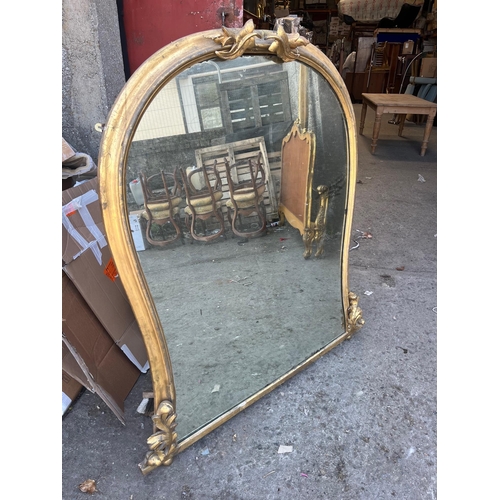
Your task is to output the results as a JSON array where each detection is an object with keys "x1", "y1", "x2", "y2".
[{"x1": 62, "y1": 178, "x2": 149, "y2": 373}]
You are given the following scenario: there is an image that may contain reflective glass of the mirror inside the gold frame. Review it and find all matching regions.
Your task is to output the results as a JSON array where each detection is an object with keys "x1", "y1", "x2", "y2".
[{"x1": 126, "y1": 56, "x2": 348, "y2": 441}]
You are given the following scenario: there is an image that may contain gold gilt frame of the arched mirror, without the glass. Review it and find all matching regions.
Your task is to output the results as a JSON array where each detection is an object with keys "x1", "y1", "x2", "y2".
[{"x1": 98, "y1": 21, "x2": 364, "y2": 474}]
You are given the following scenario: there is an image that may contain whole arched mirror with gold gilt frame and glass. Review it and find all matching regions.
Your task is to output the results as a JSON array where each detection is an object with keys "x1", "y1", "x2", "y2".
[{"x1": 99, "y1": 21, "x2": 364, "y2": 474}]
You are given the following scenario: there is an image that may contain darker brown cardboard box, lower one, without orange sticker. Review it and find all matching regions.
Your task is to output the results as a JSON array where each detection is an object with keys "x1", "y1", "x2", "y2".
[{"x1": 62, "y1": 273, "x2": 140, "y2": 424}]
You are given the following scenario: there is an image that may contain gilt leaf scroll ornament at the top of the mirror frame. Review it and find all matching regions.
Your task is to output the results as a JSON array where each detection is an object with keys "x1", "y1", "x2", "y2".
[{"x1": 212, "y1": 19, "x2": 309, "y2": 62}]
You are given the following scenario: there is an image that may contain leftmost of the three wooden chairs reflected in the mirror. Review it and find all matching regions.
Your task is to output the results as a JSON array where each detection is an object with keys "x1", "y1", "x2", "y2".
[{"x1": 139, "y1": 169, "x2": 184, "y2": 246}]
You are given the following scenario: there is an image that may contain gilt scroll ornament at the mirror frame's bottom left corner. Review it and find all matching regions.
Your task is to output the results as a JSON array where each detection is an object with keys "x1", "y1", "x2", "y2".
[{"x1": 139, "y1": 401, "x2": 177, "y2": 474}]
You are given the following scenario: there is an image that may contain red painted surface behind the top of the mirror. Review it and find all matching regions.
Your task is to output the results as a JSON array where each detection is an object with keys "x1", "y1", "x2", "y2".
[{"x1": 123, "y1": 0, "x2": 243, "y2": 73}]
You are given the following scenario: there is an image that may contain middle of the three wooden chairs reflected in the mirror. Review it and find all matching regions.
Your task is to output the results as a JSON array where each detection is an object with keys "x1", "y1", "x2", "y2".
[{"x1": 180, "y1": 162, "x2": 225, "y2": 242}]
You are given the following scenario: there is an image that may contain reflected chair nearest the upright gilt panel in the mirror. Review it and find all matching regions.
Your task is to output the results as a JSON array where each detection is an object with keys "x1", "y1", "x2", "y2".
[{"x1": 224, "y1": 153, "x2": 266, "y2": 238}]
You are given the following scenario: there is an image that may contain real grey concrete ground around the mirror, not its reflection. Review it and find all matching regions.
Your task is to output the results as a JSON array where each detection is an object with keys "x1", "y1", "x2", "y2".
[{"x1": 62, "y1": 104, "x2": 437, "y2": 500}]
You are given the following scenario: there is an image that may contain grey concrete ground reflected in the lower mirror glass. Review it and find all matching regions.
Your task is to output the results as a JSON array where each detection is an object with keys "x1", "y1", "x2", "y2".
[{"x1": 138, "y1": 224, "x2": 343, "y2": 439}]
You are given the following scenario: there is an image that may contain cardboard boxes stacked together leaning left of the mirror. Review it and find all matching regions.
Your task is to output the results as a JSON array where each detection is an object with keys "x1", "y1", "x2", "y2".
[{"x1": 62, "y1": 139, "x2": 149, "y2": 423}]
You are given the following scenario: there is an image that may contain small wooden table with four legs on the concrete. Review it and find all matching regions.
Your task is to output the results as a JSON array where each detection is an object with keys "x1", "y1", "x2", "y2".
[{"x1": 359, "y1": 94, "x2": 437, "y2": 156}]
